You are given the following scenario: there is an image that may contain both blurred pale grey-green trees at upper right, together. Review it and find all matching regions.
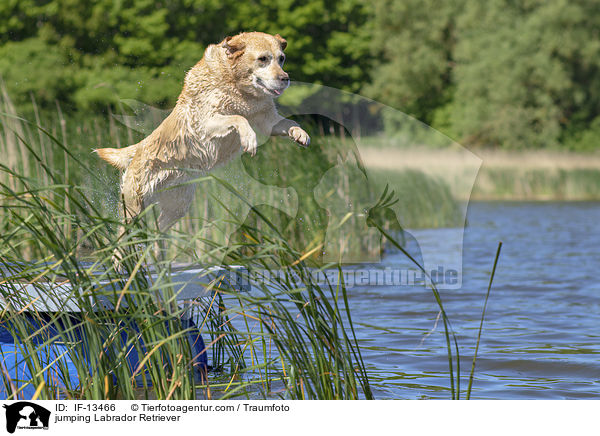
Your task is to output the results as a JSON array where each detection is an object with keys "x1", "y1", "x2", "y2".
[{"x1": 365, "y1": 0, "x2": 600, "y2": 148}]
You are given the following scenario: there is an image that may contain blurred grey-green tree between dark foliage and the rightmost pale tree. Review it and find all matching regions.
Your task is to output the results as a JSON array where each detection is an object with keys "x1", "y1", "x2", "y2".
[{"x1": 365, "y1": 0, "x2": 464, "y2": 123}]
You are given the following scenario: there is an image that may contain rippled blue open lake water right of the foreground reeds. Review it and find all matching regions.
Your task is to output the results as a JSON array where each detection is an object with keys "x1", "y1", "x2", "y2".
[{"x1": 350, "y1": 202, "x2": 600, "y2": 399}]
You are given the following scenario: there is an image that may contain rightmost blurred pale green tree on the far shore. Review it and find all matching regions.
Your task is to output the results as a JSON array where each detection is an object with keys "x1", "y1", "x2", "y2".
[{"x1": 450, "y1": 0, "x2": 600, "y2": 147}]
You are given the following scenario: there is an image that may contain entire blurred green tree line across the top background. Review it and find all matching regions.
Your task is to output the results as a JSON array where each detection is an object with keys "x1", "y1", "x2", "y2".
[{"x1": 0, "y1": 0, "x2": 600, "y2": 150}]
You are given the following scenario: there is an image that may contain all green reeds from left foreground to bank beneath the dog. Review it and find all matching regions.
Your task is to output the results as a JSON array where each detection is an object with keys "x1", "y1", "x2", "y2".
[{"x1": 0, "y1": 92, "x2": 502, "y2": 399}]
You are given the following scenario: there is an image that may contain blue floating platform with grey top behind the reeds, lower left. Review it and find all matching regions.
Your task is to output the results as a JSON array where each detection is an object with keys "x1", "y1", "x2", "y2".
[{"x1": 0, "y1": 268, "x2": 249, "y2": 399}]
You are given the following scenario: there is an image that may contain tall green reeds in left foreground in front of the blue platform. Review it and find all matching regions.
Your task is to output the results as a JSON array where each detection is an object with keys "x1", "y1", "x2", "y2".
[{"x1": 0, "y1": 111, "x2": 372, "y2": 399}]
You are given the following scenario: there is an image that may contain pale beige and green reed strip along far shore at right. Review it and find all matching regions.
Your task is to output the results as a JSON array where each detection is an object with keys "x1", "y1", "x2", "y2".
[{"x1": 358, "y1": 146, "x2": 600, "y2": 201}]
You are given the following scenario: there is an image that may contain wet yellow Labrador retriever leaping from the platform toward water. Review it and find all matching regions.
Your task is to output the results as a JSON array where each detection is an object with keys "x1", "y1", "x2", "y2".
[{"x1": 96, "y1": 32, "x2": 310, "y2": 231}]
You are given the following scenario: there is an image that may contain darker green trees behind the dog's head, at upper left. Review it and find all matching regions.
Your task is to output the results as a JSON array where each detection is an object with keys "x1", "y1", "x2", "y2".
[{"x1": 0, "y1": 0, "x2": 371, "y2": 110}]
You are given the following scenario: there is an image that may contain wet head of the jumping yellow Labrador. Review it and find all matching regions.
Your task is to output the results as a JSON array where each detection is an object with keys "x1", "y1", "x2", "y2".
[{"x1": 219, "y1": 32, "x2": 290, "y2": 98}]
